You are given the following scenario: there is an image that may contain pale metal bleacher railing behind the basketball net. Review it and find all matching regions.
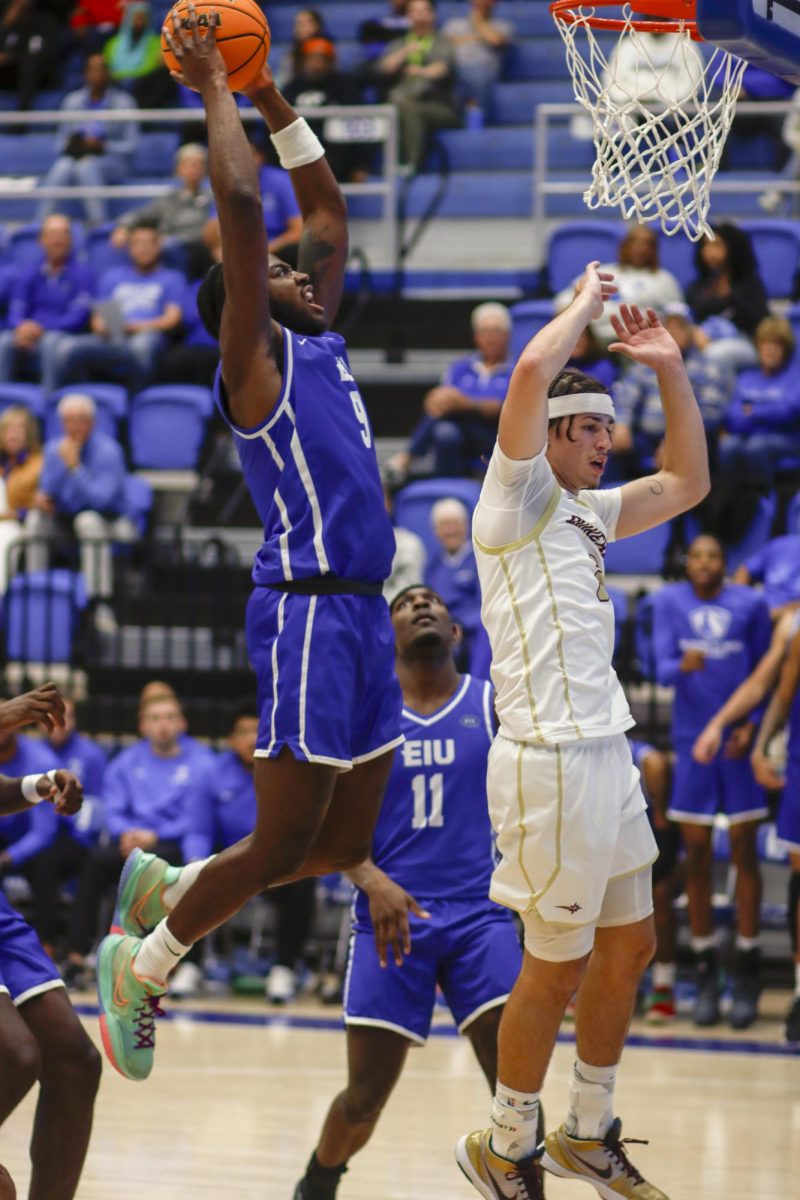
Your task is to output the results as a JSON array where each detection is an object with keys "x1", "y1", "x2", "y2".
[{"x1": 533, "y1": 100, "x2": 800, "y2": 221}]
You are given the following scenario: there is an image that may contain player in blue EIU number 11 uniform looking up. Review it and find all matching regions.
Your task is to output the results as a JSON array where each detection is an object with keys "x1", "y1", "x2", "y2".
[{"x1": 294, "y1": 584, "x2": 522, "y2": 1200}]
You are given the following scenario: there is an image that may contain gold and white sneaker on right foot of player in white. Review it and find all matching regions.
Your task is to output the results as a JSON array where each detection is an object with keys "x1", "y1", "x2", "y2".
[{"x1": 544, "y1": 1117, "x2": 669, "y2": 1200}]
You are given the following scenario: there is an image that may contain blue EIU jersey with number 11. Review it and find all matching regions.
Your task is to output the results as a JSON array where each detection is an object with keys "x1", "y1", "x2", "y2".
[{"x1": 356, "y1": 674, "x2": 494, "y2": 918}]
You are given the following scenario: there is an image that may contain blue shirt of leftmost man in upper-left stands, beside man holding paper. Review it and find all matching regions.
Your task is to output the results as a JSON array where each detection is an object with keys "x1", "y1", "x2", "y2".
[{"x1": 8, "y1": 258, "x2": 94, "y2": 334}]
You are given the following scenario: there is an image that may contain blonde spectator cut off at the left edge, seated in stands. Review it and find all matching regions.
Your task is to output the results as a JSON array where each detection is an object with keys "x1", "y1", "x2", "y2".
[{"x1": 0, "y1": 404, "x2": 43, "y2": 595}]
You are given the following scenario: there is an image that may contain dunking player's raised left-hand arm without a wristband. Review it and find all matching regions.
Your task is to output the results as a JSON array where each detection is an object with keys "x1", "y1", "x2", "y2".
[{"x1": 169, "y1": 4, "x2": 281, "y2": 426}]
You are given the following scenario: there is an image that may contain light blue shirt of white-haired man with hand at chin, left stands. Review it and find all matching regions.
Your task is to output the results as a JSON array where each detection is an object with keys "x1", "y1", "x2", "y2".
[{"x1": 38, "y1": 430, "x2": 126, "y2": 516}]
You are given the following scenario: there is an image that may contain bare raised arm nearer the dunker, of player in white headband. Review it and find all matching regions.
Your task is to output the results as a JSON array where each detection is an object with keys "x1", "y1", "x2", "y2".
[{"x1": 498, "y1": 263, "x2": 614, "y2": 460}]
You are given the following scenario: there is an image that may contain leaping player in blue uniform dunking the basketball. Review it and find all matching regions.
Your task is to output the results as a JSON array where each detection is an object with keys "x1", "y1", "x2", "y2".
[{"x1": 97, "y1": 5, "x2": 402, "y2": 1079}]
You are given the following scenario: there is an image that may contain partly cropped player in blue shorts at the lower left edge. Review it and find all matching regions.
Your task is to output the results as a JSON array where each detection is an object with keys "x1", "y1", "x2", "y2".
[{"x1": 0, "y1": 684, "x2": 101, "y2": 1200}]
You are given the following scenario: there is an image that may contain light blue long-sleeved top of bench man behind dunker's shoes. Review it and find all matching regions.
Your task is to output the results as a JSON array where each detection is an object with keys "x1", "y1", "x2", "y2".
[{"x1": 103, "y1": 739, "x2": 211, "y2": 841}]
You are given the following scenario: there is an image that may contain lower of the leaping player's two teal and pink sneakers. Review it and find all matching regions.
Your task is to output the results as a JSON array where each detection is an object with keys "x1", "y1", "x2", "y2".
[{"x1": 97, "y1": 934, "x2": 166, "y2": 1081}]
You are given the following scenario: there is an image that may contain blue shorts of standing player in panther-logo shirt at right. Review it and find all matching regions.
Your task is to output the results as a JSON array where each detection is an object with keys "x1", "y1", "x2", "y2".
[{"x1": 668, "y1": 743, "x2": 769, "y2": 824}]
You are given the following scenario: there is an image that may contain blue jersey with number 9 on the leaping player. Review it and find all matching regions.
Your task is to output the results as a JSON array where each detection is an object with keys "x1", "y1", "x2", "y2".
[{"x1": 213, "y1": 326, "x2": 395, "y2": 584}]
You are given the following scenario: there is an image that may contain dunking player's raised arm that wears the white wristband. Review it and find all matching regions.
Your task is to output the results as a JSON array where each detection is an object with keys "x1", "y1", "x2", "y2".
[{"x1": 244, "y1": 67, "x2": 348, "y2": 325}]
